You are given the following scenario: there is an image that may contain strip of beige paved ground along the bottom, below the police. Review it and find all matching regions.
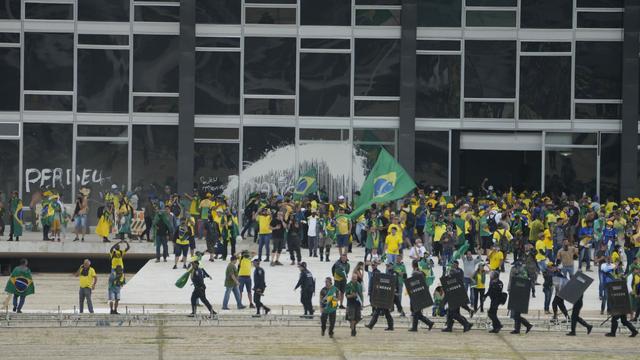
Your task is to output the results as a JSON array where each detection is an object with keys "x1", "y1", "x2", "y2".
[{"x1": 0, "y1": 325, "x2": 639, "y2": 360}]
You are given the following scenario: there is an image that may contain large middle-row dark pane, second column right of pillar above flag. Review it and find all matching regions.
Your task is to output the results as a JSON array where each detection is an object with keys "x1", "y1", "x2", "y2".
[{"x1": 464, "y1": 40, "x2": 516, "y2": 98}]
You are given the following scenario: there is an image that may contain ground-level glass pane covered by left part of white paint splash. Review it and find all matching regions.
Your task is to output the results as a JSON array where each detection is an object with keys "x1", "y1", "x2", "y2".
[{"x1": 241, "y1": 127, "x2": 298, "y2": 200}]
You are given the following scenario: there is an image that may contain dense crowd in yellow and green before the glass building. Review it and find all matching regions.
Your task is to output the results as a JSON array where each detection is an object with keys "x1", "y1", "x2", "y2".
[{"x1": 3, "y1": 183, "x2": 640, "y2": 336}]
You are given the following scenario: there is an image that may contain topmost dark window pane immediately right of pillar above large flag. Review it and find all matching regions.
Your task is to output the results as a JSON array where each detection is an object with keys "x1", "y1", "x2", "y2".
[{"x1": 418, "y1": 0, "x2": 462, "y2": 27}]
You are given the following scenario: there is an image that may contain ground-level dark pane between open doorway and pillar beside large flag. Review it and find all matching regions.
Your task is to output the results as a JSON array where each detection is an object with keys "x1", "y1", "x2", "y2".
[{"x1": 414, "y1": 131, "x2": 449, "y2": 191}]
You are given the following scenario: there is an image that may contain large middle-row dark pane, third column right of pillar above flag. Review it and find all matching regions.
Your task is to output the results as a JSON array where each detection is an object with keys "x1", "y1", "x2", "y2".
[{"x1": 520, "y1": 56, "x2": 571, "y2": 119}]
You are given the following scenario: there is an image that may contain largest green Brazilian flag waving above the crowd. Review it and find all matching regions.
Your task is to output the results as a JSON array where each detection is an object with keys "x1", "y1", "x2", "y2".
[{"x1": 349, "y1": 148, "x2": 416, "y2": 219}]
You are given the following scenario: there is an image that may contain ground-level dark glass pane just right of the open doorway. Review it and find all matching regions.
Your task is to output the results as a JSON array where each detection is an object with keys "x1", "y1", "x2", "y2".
[{"x1": 545, "y1": 148, "x2": 598, "y2": 196}]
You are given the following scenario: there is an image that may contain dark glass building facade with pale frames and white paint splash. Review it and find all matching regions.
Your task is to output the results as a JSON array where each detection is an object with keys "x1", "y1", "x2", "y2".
[{"x1": 0, "y1": 0, "x2": 640, "y2": 202}]
